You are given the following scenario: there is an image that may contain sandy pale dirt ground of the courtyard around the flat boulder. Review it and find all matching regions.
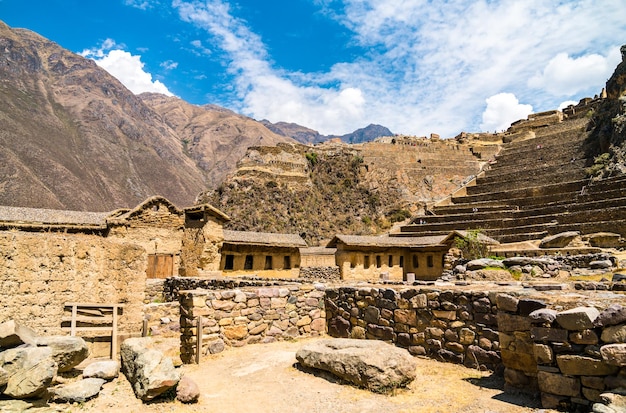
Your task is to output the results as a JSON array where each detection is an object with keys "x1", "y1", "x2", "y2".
[{"x1": 67, "y1": 339, "x2": 547, "y2": 413}]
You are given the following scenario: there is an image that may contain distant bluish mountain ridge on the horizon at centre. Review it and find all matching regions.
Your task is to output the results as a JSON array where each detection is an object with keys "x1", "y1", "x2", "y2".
[{"x1": 261, "y1": 119, "x2": 394, "y2": 145}]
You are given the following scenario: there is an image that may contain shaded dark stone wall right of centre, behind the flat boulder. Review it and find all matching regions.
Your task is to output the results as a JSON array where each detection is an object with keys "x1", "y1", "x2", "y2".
[{"x1": 325, "y1": 287, "x2": 501, "y2": 369}]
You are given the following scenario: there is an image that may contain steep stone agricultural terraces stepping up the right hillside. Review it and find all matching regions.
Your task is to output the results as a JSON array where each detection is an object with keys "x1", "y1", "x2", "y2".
[{"x1": 391, "y1": 118, "x2": 626, "y2": 243}]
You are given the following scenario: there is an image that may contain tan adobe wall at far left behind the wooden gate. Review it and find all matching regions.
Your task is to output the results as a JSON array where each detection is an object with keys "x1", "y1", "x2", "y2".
[{"x1": 0, "y1": 231, "x2": 147, "y2": 335}]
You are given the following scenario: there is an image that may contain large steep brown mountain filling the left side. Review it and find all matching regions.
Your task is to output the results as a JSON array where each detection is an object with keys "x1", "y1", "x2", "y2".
[{"x1": 0, "y1": 22, "x2": 206, "y2": 211}]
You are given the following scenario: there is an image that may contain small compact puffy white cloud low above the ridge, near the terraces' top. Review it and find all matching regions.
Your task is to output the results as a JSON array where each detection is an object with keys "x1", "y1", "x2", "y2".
[{"x1": 480, "y1": 93, "x2": 533, "y2": 132}]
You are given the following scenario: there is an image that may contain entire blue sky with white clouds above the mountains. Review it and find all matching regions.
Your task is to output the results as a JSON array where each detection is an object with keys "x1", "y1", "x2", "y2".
[{"x1": 0, "y1": 0, "x2": 626, "y2": 138}]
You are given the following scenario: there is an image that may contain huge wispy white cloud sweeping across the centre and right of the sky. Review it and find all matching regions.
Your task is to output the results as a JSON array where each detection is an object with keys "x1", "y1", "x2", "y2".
[{"x1": 168, "y1": 0, "x2": 626, "y2": 137}]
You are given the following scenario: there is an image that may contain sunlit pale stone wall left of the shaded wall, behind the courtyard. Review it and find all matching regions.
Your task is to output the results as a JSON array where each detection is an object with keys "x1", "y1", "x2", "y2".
[{"x1": 179, "y1": 284, "x2": 326, "y2": 363}]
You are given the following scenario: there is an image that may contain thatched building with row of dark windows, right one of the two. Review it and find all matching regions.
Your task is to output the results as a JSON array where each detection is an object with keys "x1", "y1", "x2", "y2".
[{"x1": 328, "y1": 234, "x2": 454, "y2": 281}]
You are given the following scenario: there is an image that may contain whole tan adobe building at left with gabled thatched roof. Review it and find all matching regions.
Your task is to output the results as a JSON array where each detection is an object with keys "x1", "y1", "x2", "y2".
[{"x1": 0, "y1": 197, "x2": 229, "y2": 350}]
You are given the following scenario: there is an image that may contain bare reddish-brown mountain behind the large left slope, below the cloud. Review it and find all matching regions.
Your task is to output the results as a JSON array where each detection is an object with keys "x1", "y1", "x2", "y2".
[{"x1": 139, "y1": 93, "x2": 294, "y2": 188}]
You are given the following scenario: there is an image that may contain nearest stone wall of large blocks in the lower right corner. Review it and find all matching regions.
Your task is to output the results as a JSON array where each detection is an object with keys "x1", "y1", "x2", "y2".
[{"x1": 496, "y1": 293, "x2": 626, "y2": 411}]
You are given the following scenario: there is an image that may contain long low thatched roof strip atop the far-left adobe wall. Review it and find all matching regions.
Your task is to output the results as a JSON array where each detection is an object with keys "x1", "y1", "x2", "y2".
[{"x1": 0, "y1": 206, "x2": 111, "y2": 229}]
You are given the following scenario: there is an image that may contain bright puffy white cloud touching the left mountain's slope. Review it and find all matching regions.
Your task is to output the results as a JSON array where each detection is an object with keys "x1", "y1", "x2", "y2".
[{"x1": 80, "y1": 39, "x2": 173, "y2": 96}]
